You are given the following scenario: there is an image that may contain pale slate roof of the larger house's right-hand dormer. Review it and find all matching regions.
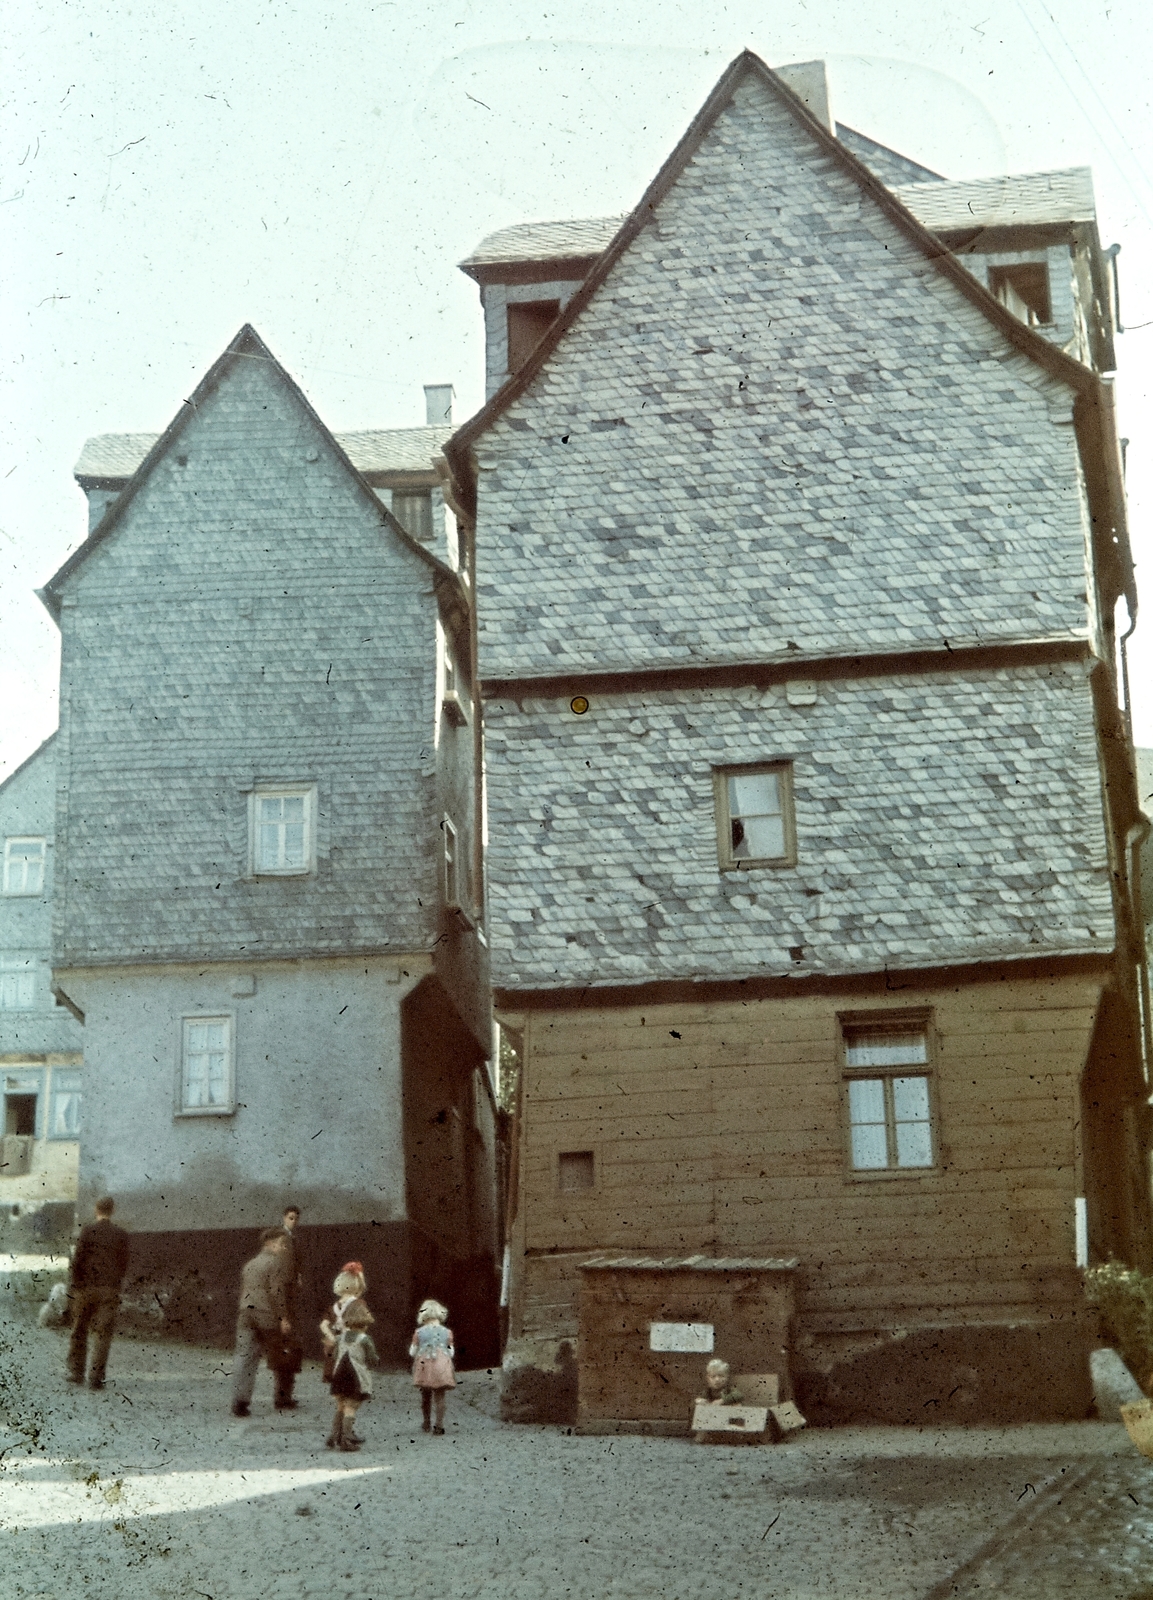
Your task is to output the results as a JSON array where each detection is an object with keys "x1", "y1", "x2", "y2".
[{"x1": 894, "y1": 166, "x2": 1097, "y2": 234}]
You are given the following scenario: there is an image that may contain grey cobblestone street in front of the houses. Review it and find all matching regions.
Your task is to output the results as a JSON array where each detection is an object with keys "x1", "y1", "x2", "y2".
[{"x1": 0, "y1": 1315, "x2": 1153, "y2": 1600}]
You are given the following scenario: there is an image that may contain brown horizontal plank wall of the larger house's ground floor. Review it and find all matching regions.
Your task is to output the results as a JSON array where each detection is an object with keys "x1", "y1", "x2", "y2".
[{"x1": 518, "y1": 978, "x2": 1100, "y2": 1338}]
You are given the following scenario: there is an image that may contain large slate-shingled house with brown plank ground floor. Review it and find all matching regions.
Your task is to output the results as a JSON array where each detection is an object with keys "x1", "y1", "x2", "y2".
[{"x1": 446, "y1": 54, "x2": 1150, "y2": 1419}]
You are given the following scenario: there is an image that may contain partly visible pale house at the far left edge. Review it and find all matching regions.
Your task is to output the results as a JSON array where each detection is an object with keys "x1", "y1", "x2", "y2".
[{"x1": 0, "y1": 734, "x2": 83, "y2": 1228}]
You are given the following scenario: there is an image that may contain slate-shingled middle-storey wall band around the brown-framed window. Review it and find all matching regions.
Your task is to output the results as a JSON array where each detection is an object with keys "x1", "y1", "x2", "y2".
[{"x1": 486, "y1": 666, "x2": 1113, "y2": 989}]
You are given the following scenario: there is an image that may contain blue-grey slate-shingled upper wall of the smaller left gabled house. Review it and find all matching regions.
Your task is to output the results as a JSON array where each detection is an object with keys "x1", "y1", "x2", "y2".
[{"x1": 54, "y1": 358, "x2": 438, "y2": 966}]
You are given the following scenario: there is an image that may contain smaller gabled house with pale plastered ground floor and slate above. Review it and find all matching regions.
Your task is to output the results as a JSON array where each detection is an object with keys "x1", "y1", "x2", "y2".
[{"x1": 43, "y1": 328, "x2": 496, "y2": 1360}]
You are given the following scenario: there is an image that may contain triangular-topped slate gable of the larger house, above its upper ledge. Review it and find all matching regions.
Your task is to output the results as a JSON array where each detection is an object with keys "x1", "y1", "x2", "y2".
[{"x1": 449, "y1": 58, "x2": 1089, "y2": 680}]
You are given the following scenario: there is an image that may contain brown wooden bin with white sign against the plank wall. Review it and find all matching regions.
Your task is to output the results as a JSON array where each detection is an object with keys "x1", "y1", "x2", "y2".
[{"x1": 577, "y1": 1256, "x2": 798, "y2": 1434}]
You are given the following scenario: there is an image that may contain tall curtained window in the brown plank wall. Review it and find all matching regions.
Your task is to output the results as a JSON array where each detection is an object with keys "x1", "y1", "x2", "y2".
[{"x1": 843, "y1": 1019, "x2": 936, "y2": 1173}]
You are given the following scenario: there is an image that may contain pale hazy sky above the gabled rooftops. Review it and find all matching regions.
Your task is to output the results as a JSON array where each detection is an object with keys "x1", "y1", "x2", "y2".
[{"x1": 0, "y1": 0, "x2": 1153, "y2": 779}]
